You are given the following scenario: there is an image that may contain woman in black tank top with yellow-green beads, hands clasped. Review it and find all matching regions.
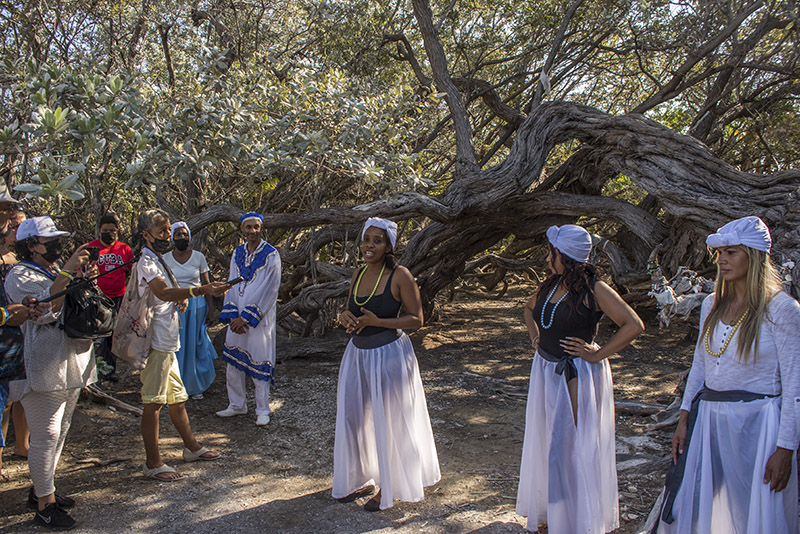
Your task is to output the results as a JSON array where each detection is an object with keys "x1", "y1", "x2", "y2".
[{"x1": 332, "y1": 217, "x2": 440, "y2": 511}]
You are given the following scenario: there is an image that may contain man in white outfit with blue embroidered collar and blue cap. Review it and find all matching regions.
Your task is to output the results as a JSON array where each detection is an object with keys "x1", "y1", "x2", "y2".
[{"x1": 217, "y1": 213, "x2": 281, "y2": 426}]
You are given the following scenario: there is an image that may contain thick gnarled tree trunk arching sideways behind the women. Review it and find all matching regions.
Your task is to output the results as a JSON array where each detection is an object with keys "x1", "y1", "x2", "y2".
[{"x1": 183, "y1": 101, "x2": 800, "y2": 330}]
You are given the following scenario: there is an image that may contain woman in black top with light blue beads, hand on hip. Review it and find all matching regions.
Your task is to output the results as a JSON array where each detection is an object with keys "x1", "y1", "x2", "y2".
[{"x1": 516, "y1": 224, "x2": 644, "y2": 534}]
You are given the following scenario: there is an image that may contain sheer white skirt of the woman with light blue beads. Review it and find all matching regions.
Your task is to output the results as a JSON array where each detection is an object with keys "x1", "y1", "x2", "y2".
[{"x1": 517, "y1": 352, "x2": 619, "y2": 534}]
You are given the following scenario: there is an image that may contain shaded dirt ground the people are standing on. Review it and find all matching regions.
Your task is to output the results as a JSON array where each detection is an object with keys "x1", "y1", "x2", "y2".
[{"x1": 0, "y1": 288, "x2": 693, "y2": 534}]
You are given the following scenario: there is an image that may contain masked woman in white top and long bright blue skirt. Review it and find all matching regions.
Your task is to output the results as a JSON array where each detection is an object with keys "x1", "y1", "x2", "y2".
[{"x1": 164, "y1": 221, "x2": 217, "y2": 400}]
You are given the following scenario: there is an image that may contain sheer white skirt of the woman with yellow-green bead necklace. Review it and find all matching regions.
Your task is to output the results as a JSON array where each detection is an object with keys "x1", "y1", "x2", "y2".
[{"x1": 332, "y1": 334, "x2": 441, "y2": 509}]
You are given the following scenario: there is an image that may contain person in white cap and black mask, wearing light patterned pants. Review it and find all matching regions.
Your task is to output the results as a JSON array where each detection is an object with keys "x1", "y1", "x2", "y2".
[{"x1": 5, "y1": 217, "x2": 97, "y2": 529}]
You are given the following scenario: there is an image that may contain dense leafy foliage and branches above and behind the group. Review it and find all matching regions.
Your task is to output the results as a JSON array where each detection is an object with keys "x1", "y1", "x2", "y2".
[{"x1": 0, "y1": 0, "x2": 800, "y2": 330}]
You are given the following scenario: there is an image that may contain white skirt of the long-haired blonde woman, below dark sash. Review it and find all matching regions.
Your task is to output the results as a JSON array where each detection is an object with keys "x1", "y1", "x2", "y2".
[{"x1": 658, "y1": 397, "x2": 798, "y2": 534}]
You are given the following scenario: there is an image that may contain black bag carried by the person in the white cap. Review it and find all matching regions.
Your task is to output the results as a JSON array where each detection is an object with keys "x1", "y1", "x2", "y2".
[{"x1": 58, "y1": 278, "x2": 117, "y2": 339}]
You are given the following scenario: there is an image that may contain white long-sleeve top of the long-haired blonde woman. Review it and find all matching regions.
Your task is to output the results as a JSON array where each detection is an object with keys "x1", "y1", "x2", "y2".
[{"x1": 681, "y1": 291, "x2": 800, "y2": 450}]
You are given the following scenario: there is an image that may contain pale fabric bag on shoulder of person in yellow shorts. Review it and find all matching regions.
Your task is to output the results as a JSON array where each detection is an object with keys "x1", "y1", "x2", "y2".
[{"x1": 111, "y1": 265, "x2": 155, "y2": 369}]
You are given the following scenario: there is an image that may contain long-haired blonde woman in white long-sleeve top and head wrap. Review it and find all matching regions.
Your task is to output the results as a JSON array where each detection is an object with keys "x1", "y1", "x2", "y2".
[{"x1": 655, "y1": 216, "x2": 800, "y2": 534}]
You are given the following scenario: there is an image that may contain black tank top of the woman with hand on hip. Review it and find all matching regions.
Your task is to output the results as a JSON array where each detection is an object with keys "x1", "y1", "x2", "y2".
[{"x1": 533, "y1": 288, "x2": 603, "y2": 358}]
